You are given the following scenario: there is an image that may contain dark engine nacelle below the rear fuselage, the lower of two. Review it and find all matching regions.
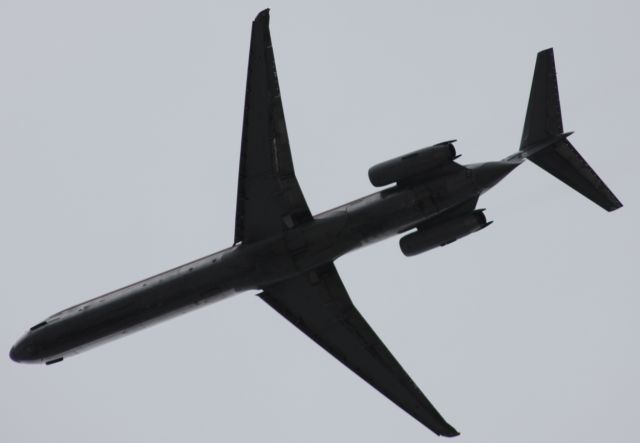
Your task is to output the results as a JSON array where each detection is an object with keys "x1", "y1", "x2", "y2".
[{"x1": 400, "y1": 211, "x2": 491, "y2": 257}]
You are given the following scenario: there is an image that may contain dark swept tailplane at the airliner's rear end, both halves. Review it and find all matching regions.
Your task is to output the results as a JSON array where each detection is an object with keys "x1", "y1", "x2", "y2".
[{"x1": 520, "y1": 48, "x2": 622, "y2": 211}]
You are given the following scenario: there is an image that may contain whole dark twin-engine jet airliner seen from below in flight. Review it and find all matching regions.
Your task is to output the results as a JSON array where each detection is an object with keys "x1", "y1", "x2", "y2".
[{"x1": 10, "y1": 10, "x2": 622, "y2": 437}]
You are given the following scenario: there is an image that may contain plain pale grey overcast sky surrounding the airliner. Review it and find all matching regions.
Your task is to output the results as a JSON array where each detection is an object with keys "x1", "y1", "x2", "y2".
[{"x1": 0, "y1": 0, "x2": 640, "y2": 443}]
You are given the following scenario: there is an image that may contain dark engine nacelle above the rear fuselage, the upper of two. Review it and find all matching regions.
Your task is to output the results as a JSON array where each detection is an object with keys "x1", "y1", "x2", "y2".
[{"x1": 369, "y1": 140, "x2": 456, "y2": 186}]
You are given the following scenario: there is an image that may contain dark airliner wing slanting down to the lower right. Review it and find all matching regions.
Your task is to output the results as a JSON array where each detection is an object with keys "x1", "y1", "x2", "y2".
[{"x1": 260, "y1": 264, "x2": 459, "y2": 437}]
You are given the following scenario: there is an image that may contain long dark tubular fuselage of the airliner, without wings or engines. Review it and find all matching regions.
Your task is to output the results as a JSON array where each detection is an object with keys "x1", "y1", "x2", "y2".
[{"x1": 11, "y1": 162, "x2": 500, "y2": 363}]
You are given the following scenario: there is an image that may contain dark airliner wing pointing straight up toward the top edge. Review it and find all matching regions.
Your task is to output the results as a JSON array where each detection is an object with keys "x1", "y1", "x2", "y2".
[{"x1": 234, "y1": 9, "x2": 312, "y2": 243}]
